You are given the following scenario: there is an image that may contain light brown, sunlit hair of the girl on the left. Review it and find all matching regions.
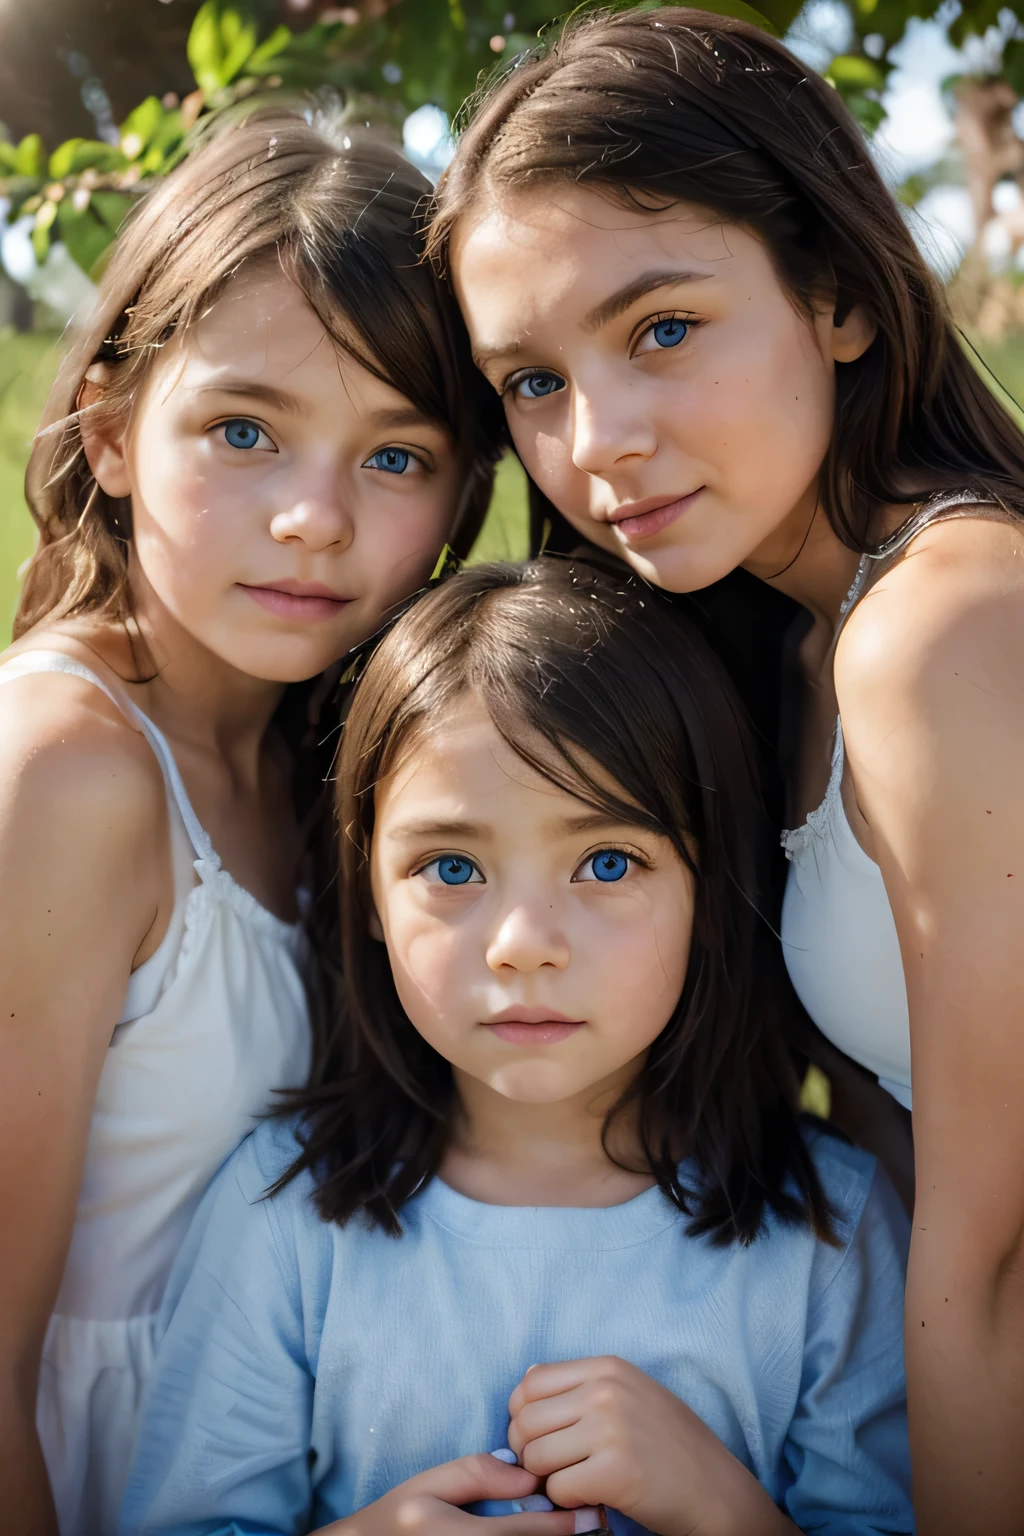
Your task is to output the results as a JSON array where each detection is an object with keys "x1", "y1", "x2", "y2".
[{"x1": 14, "y1": 106, "x2": 500, "y2": 637}]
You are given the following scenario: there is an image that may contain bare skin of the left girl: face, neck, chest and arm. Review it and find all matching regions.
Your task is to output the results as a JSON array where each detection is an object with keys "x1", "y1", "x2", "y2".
[{"x1": 0, "y1": 263, "x2": 466, "y2": 1536}]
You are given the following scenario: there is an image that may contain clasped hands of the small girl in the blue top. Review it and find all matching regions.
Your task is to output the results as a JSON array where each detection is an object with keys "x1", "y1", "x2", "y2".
[{"x1": 321, "y1": 1355, "x2": 795, "y2": 1536}]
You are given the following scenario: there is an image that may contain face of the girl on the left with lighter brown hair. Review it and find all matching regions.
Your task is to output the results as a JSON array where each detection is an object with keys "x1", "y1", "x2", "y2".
[{"x1": 89, "y1": 267, "x2": 459, "y2": 682}]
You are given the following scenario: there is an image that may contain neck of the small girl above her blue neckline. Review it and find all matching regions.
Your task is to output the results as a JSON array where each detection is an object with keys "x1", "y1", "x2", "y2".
[{"x1": 441, "y1": 1061, "x2": 652, "y2": 1206}]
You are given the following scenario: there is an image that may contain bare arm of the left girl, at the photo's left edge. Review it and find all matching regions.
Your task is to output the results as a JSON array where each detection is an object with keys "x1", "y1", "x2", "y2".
[{"x1": 0, "y1": 677, "x2": 167, "y2": 1536}]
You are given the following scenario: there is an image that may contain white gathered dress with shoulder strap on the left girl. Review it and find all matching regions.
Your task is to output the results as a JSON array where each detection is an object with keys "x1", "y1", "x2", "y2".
[{"x1": 0, "y1": 651, "x2": 310, "y2": 1536}]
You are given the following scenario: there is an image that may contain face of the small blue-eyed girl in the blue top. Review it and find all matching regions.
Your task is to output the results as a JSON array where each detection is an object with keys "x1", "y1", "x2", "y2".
[{"x1": 372, "y1": 696, "x2": 694, "y2": 1103}]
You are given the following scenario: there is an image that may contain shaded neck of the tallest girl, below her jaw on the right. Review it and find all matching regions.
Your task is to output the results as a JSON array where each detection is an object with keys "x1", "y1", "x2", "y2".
[{"x1": 745, "y1": 488, "x2": 860, "y2": 633}]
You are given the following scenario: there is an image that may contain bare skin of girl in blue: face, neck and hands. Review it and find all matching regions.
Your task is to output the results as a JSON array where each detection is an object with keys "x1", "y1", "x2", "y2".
[{"x1": 348, "y1": 694, "x2": 795, "y2": 1536}]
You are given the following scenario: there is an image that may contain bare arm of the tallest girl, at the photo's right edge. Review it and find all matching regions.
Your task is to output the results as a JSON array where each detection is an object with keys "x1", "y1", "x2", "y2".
[{"x1": 835, "y1": 525, "x2": 1024, "y2": 1536}]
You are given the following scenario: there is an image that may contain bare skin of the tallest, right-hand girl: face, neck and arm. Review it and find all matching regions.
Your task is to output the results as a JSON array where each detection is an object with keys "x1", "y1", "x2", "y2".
[{"x1": 453, "y1": 183, "x2": 1024, "y2": 1536}]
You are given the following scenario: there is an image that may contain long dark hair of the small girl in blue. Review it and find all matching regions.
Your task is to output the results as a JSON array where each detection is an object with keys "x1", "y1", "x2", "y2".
[{"x1": 282, "y1": 556, "x2": 829, "y2": 1243}]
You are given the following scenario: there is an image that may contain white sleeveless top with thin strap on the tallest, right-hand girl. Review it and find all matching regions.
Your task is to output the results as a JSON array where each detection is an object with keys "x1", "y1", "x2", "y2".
[{"x1": 781, "y1": 493, "x2": 1001, "y2": 1109}]
